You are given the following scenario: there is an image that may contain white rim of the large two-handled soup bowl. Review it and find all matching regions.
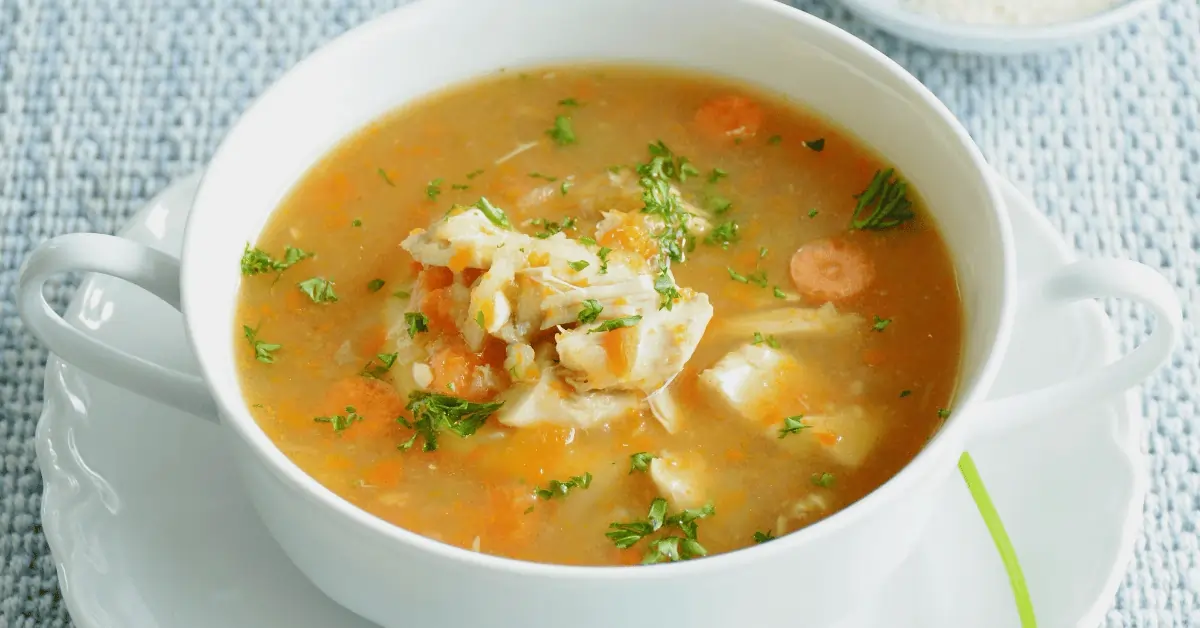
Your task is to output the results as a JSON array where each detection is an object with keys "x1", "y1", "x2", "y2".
[{"x1": 180, "y1": 0, "x2": 1015, "y2": 581}]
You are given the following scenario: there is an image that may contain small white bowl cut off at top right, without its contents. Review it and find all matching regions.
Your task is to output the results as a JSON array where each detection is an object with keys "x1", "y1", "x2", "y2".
[{"x1": 842, "y1": 0, "x2": 1159, "y2": 54}]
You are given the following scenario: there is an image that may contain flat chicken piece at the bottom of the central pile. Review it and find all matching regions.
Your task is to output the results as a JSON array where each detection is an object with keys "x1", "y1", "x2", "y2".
[{"x1": 496, "y1": 365, "x2": 638, "y2": 429}]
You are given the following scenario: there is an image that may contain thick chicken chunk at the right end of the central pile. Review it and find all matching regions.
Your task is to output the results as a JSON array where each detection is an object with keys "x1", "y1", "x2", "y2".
[{"x1": 556, "y1": 293, "x2": 713, "y2": 393}]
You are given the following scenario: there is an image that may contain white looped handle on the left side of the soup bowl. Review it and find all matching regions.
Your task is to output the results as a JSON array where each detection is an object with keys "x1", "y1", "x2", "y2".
[{"x1": 17, "y1": 233, "x2": 217, "y2": 421}]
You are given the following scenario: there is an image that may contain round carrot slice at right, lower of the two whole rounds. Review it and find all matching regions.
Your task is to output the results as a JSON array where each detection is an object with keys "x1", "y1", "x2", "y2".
[{"x1": 791, "y1": 240, "x2": 875, "y2": 301}]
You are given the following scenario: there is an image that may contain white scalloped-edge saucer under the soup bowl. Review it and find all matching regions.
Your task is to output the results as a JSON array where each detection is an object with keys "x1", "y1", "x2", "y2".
[{"x1": 37, "y1": 171, "x2": 1146, "y2": 628}]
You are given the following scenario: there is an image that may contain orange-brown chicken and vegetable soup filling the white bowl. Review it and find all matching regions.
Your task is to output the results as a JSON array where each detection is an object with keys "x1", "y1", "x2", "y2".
[{"x1": 235, "y1": 66, "x2": 961, "y2": 564}]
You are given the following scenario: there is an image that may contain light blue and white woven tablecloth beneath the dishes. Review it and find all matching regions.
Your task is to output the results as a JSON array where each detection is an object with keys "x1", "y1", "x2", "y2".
[{"x1": 0, "y1": 0, "x2": 1200, "y2": 628}]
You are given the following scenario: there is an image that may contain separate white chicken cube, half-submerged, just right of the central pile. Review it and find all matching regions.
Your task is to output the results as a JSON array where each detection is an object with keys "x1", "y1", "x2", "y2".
[{"x1": 700, "y1": 343, "x2": 799, "y2": 423}]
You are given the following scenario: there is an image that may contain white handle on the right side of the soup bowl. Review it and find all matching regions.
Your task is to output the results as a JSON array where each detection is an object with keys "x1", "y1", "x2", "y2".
[{"x1": 970, "y1": 259, "x2": 1183, "y2": 437}]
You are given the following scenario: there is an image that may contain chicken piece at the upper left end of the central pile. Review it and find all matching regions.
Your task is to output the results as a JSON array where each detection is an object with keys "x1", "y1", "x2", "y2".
[{"x1": 400, "y1": 208, "x2": 533, "y2": 270}]
